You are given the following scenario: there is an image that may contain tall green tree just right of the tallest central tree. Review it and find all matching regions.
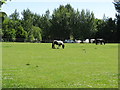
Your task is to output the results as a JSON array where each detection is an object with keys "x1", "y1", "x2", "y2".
[{"x1": 75, "y1": 9, "x2": 97, "y2": 40}]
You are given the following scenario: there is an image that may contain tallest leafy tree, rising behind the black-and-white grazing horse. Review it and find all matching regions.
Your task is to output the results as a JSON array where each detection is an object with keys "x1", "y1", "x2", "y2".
[{"x1": 51, "y1": 4, "x2": 74, "y2": 40}]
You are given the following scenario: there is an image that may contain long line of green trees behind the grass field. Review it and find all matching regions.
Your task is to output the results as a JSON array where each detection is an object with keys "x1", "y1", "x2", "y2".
[{"x1": 0, "y1": 4, "x2": 120, "y2": 42}]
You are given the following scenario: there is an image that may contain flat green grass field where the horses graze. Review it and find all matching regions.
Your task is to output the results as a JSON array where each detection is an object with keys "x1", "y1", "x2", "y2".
[{"x1": 2, "y1": 43, "x2": 118, "y2": 88}]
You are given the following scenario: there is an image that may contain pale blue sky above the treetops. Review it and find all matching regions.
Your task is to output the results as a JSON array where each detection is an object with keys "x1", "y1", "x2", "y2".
[{"x1": 2, "y1": 0, "x2": 117, "y2": 19}]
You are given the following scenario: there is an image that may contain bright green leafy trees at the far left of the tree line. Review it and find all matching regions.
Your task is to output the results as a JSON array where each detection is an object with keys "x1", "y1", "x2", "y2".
[{"x1": 3, "y1": 10, "x2": 27, "y2": 42}]
